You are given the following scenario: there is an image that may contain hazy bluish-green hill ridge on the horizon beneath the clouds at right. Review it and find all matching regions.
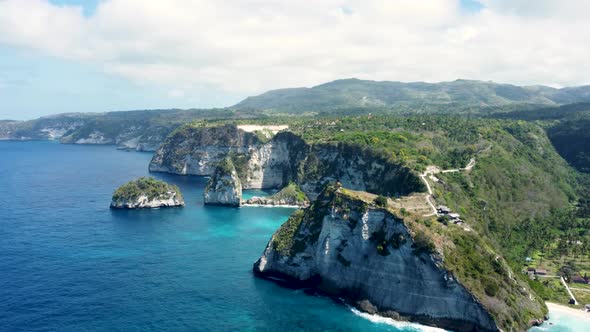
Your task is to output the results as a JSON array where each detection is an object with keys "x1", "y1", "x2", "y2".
[{"x1": 233, "y1": 79, "x2": 590, "y2": 113}]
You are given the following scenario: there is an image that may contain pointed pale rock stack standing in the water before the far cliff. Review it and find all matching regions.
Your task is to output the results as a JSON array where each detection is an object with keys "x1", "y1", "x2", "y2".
[{"x1": 203, "y1": 158, "x2": 242, "y2": 207}]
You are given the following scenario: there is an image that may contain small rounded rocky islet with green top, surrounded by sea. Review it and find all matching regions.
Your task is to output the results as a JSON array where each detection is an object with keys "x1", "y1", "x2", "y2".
[{"x1": 111, "y1": 177, "x2": 184, "y2": 209}]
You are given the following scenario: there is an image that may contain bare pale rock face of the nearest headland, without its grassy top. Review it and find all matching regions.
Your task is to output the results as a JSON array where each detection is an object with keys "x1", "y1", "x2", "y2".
[{"x1": 254, "y1": 192, "x2": 498, "y2": 331}]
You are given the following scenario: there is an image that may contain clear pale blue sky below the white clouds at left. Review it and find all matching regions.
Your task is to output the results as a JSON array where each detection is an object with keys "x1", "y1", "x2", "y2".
[{"x1": 0, "y1": 47, "x2": 239, "y2": 120}]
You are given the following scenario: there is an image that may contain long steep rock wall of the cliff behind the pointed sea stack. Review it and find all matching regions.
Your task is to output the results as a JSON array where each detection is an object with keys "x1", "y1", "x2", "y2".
[{"x1": 149, "y1": 125, "x2": 425, "y2": 197}]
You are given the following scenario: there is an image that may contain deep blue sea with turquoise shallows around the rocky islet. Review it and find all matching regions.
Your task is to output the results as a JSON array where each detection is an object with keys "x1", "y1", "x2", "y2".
[{"x1": 0, "y1": 142, "x2": 584, "y2": 332}]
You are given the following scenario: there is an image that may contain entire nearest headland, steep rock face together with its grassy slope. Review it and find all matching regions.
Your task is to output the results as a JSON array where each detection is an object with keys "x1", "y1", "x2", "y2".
[{"x1": 254, "y1": 188, "x2": 543, "y2": 331}]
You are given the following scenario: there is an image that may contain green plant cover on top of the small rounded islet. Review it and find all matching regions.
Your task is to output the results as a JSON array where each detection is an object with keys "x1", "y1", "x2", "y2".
[{"x1": 113, "y1": 177, "x2": 182, "y2": 202}]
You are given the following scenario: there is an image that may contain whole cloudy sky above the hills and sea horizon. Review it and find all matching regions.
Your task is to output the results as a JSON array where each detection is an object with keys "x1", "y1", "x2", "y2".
[{"x1": 0, "y1": 0, "x2": 590, "y2": 120}]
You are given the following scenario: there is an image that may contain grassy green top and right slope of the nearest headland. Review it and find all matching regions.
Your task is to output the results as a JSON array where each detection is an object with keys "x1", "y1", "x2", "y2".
[{"x1": 332, "y1": 188, "x2": 547, "y2": 331}]
